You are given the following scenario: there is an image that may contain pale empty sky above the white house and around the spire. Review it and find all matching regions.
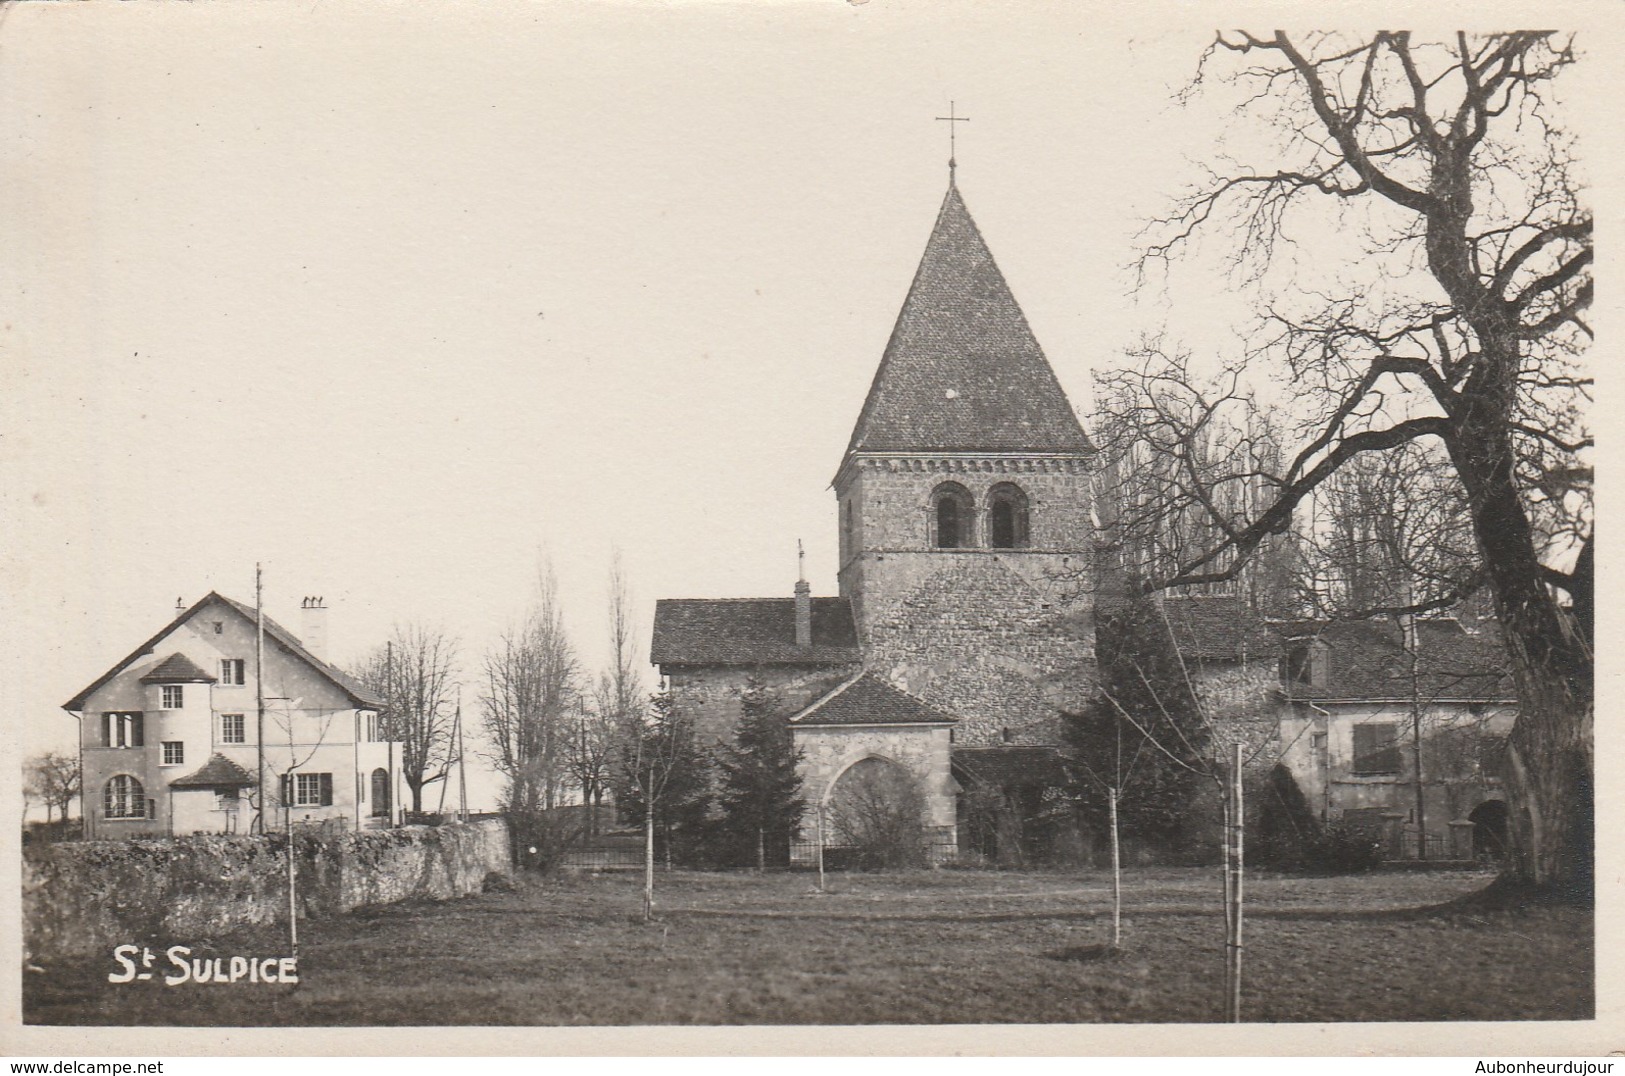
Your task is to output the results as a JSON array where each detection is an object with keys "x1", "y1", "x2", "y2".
[{"x1": 0, "y1": 2, "x2": 1612, "y2": 805}]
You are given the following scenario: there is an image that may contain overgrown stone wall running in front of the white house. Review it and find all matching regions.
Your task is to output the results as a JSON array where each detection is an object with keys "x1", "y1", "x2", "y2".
[{"x1": 23, "y1": 819, "x2": 512, "y2": 959}]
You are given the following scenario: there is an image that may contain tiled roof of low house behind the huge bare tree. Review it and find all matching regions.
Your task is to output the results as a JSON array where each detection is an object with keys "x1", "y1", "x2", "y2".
[{"x1": 1282, "y1": 619, "x2": 1516, "y2": 702}]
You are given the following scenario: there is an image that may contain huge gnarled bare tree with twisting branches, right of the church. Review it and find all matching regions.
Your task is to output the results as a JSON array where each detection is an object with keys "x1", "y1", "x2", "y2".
[{"x1": 1146, "y1": 33, "x2": 1593, "y2": 892}]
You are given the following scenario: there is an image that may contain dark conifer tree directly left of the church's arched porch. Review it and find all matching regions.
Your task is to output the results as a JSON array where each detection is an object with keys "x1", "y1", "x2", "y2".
[{"x1": 718, "y1": 676, "x2": 804, "y2": 868}]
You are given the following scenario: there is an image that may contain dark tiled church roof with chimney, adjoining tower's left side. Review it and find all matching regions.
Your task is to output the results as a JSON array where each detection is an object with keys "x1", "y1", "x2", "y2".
[{"x1": 648, "y1": 598, "x2": 863, "y2": 665}]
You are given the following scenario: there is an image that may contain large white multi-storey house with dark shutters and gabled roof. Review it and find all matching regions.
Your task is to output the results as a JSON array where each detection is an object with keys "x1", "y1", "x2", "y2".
[{"x1": 63, "y1": 593, "x2": 401, "y2": 840}]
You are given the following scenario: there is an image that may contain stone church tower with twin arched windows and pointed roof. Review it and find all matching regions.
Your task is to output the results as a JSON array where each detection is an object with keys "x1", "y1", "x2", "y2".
[{"x1": 834, "y1": 172, "x2": 1095, "y2": 744}]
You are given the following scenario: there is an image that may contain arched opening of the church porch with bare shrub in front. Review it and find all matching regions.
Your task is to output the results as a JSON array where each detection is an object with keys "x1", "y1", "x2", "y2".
[{"x1": 827, "y1": 756, "x2": 926, "y2": 870}]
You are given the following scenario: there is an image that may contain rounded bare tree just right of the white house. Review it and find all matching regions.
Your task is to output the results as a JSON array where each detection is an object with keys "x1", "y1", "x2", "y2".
[{"x1": 358, "y1": 623, "x2": 458, "y2": 813}]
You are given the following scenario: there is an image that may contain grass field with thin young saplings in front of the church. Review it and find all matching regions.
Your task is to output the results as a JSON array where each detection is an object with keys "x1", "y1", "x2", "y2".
[{"x1": 23, "y1": 870, "x2": 1594, "y2": 1026}]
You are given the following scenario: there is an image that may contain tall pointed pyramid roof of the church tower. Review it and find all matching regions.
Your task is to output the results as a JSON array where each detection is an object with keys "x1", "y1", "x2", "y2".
[{"x1": 847, "y1": 182, "x2": 1094, "y2": 455}]
